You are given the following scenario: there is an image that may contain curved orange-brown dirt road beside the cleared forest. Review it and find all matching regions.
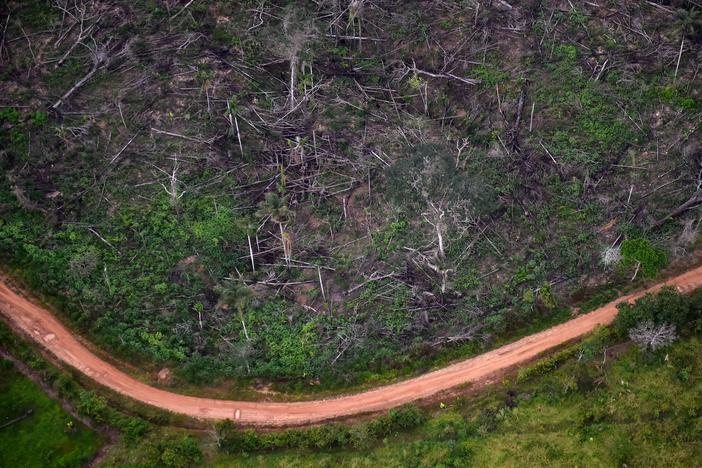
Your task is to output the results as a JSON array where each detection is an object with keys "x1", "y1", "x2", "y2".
[{"x1": 0, "y1": 267, "x2": 702, "y2": 426}]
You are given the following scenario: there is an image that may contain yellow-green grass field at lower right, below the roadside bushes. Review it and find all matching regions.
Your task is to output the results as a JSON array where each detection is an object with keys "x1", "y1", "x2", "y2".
[{"x1": 212, "y1": 330, "x2": 702, "y2": 467}]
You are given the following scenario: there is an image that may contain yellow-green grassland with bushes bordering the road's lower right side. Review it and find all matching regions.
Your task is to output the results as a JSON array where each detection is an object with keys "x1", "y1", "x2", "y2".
[{"x1": 213, "y1": 290, "x2": 702, "y2": 467}]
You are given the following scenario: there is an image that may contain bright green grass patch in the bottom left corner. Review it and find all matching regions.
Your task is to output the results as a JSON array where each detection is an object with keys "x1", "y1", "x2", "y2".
[{"x1": 0, "y1": 360, "x2": 103, "y2": 468}]
